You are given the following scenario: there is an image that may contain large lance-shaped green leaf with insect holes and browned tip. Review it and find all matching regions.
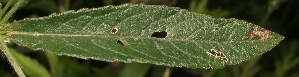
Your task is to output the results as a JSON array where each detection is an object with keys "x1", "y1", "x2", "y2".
[{"x1": 6, "y1": 4, "x2": 284, "y2": 69}]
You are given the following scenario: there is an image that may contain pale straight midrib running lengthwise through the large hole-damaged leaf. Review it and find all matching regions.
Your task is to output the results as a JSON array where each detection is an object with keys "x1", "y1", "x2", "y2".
[{"x1": 6, "y1": 31, "x2": 270, "y2": 44}]
